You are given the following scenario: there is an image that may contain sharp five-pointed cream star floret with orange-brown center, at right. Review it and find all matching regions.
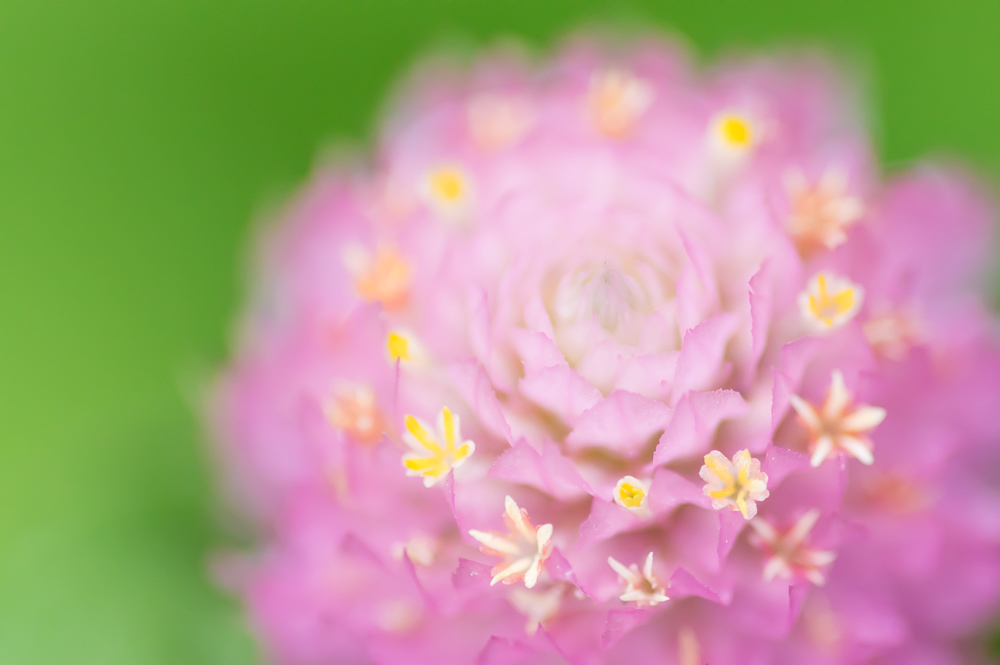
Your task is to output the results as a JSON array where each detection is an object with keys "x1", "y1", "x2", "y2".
[{"x1": 789, "y1": 370, "x2": 885, "y2": 466}]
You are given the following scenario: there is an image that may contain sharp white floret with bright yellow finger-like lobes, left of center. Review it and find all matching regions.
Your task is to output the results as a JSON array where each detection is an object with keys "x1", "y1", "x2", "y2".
[{"x1": 403, "y1": 407, "x2": 476, "y2": 487}]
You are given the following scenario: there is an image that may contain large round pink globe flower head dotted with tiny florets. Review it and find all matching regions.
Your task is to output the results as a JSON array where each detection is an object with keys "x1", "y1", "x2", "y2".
[{"x1": 213, "y1": 40, "x2": 1000, "y2": 665}]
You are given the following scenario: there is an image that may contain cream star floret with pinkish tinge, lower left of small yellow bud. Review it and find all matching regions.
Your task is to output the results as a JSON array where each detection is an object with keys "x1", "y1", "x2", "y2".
[{"x1": 469, "y1": 496, "x2": 552, "y2": 589}]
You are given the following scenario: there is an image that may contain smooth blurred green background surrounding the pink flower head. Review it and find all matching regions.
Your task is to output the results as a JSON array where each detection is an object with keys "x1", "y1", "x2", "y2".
[{"x1": 0, "y1": 0, "x2": 1000, "y2": 665}]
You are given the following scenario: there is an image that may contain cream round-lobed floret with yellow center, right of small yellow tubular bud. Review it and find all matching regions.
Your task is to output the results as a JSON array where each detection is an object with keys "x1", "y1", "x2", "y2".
[{"x1": 698, "y1": 449, "x2": 770, "y2": 519}]
